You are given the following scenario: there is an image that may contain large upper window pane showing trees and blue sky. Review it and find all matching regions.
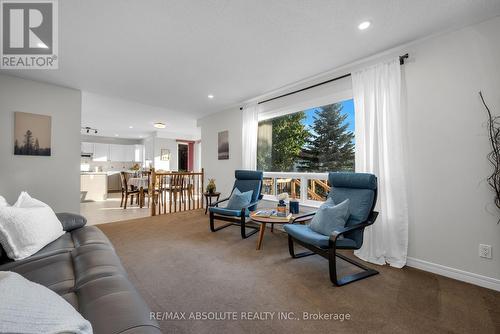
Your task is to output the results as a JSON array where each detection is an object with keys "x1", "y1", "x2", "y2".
[{"x1": 257, "y1": 99, "x2": 355, "y2": 173}]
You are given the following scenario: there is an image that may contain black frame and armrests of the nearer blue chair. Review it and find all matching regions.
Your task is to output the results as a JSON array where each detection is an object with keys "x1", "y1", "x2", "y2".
[{"x1": 288, "y1": 190, "x2": 379, "y2": 286}]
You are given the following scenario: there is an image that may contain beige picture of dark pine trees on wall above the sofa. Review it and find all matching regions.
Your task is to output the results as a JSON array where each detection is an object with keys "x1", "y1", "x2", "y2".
[{"x1": 14, "y1": 112, "x2": 52, "y2": 156}]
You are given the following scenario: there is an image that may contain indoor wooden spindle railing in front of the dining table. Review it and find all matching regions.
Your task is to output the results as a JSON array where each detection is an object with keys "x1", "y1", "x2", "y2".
[{"x1": 149, "y1": 168, "x2": 204, "y2": 216}]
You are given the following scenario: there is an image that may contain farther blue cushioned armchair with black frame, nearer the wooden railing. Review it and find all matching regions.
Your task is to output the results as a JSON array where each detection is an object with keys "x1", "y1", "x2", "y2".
[{"x1": 209, "y1": 170, "x2": 264, "y2": 239}]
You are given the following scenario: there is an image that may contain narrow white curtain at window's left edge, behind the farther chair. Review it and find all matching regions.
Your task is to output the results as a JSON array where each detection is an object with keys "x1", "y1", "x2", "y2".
[{"x1": 241, "y1": 104, "x2": 259, "y2": 170}]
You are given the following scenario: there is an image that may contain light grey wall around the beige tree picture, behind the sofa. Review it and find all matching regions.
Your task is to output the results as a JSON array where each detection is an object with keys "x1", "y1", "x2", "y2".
[{"x1": 0, "y1": 75, "x2": 81, "y2": 213}]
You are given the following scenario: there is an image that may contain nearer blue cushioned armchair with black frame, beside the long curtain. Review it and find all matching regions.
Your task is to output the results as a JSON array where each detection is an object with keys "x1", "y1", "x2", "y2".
[{"x1": 284, "y1": 173, "x2": 378, "y2": 286}]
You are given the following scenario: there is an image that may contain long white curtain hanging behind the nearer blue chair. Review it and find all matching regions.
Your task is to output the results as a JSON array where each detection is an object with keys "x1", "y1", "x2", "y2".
[{"x1": 352, "y1": 58, "x2": 408, "y2": 268}]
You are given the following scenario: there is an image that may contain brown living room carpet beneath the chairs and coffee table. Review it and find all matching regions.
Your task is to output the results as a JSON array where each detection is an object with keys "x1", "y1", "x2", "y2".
[{"x1": 99, "y1": 210, "x2": 500, "y2": 333}]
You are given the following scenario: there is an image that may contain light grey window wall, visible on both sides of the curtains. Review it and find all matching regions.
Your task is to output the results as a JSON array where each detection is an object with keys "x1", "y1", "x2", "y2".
[{"x1": 199, "y1": 18, "x2": 500, "y2": 287}]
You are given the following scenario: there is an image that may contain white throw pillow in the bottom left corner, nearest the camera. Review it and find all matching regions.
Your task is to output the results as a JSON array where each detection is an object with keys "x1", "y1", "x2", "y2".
[{"x1": 0, "y1": 271, "x2": 92, "y2": 334}]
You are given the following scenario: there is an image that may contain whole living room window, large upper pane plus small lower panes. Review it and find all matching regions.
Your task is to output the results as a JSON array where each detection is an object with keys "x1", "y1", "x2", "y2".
[{"x1": 257, "y1": 99, "x2": 355, "y2": 205}]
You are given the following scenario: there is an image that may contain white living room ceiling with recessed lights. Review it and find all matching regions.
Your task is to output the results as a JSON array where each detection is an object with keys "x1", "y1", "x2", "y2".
[{"x1": 5, "y1": 0, "x2": 500, "y2": 119}]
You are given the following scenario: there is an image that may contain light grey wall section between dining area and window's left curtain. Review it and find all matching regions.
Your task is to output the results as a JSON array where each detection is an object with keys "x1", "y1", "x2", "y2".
[{"x1": 198, "y1": 108, "x2": 242, "y2": 198}]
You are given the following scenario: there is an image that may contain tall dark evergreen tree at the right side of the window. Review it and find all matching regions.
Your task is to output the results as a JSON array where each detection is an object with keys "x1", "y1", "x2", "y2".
[{"x1": 299, "y1": 103, "x2": 354, "y2": 172}]
